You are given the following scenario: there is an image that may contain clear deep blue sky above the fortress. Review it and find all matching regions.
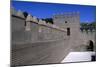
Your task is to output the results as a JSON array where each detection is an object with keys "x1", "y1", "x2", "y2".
[{"x1": 11, "y1": 1, "x2": 96, "y2": 22}]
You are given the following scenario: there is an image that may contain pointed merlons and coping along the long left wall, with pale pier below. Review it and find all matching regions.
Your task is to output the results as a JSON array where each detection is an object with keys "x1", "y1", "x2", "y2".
[{"x1": 11, "y1": 8, "x2": 66, "y2": 32}]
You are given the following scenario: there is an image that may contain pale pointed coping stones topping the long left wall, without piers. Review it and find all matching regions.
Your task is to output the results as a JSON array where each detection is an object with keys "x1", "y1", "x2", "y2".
[{"x1": 11, "y1": 8, "x2": 69, "y2": 32}]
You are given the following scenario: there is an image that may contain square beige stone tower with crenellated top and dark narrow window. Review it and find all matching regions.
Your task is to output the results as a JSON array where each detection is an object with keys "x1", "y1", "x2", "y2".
[{"x1": 53, "y1": 12, "x2": 81, "y2": 48}]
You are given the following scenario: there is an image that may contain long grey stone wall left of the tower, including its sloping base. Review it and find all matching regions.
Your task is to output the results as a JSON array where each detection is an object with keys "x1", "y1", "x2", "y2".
[{"x1": 11, "y1": 9, "x2": 70, "y2": 65}]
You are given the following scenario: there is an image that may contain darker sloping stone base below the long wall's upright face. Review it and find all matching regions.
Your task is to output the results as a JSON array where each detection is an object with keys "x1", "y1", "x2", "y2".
[{"x1": 12, "y1": 40, "x2": 70, "y2": 65}]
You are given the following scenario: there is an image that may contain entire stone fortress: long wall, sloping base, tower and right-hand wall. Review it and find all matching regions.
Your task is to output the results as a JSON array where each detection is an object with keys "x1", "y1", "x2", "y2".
[{"x1": 11, "y1": 9, "x2": 95, "y2": 65}]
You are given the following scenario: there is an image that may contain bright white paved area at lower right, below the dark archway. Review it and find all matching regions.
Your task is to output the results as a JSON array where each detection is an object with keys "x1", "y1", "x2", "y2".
[{"x1": 61, "y1": 51, "x2": 95, "y2": 63}]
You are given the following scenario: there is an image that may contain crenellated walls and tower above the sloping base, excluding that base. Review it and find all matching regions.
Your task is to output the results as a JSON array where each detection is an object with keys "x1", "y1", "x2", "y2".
[{"x1": 11, "y1": 8, "x2": 95, "y2": 48}]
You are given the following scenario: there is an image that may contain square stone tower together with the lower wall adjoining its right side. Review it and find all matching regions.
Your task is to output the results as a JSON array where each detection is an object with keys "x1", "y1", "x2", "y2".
[{"x1": 53, "y1": 12, "x2": 96, "y2": 49}]
